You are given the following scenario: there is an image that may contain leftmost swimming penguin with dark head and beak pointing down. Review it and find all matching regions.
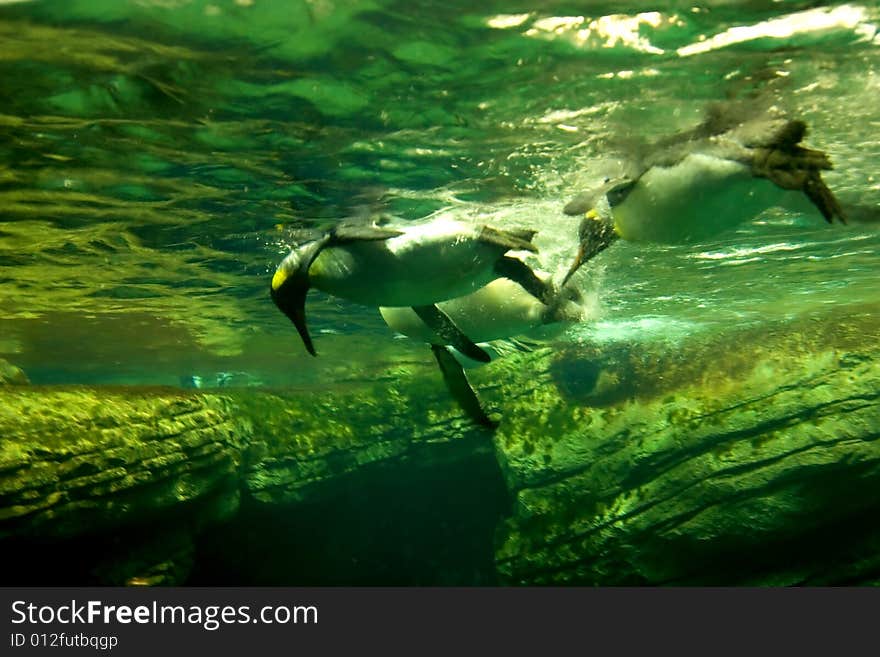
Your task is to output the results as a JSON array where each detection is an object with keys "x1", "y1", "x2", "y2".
[{"x1": 271, "y1": 216, "x2": 553, "y2": 361}]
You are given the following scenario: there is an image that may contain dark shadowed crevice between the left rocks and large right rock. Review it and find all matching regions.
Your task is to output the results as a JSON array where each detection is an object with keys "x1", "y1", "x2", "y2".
[{"x1": 186, "y1": 441, "x2": 510, "y2": 586}]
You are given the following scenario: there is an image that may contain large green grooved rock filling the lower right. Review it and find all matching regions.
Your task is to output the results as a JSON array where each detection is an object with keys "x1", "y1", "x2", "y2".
[{"x1": 496, "y1": 309, "x2": 880, "y2": 585}]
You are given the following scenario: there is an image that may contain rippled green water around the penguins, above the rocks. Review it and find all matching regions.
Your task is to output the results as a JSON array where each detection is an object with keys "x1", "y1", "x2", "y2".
[{"x1": 0, "y1": 0, "x2": 880, "y2": 385}]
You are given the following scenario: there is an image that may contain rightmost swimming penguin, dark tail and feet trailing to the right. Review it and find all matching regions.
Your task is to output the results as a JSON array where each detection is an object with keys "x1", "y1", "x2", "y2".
[{"x1": 564, "y1": 104, "x2": 846, "y2": 280}]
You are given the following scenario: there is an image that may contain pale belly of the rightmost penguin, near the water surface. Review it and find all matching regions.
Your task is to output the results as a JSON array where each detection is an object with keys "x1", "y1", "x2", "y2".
[{"x1": 613, "y1": 154, "x2": 793, "y2": 243}]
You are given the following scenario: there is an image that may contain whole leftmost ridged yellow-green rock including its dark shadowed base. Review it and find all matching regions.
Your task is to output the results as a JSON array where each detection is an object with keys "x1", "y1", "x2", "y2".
[{"x1": 0, "y1": 387, "x2": 250, "y2": 584}]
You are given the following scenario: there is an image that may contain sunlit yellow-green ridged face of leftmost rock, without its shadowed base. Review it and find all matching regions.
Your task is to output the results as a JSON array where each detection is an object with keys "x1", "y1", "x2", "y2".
[{"x1": 0, "y1": 388, "x2": 250, "y2": 538}]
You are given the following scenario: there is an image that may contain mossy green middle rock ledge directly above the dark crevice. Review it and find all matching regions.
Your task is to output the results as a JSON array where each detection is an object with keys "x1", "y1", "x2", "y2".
[{"x1": 237, "y1": 372, "x2": 491, "y2": 504}]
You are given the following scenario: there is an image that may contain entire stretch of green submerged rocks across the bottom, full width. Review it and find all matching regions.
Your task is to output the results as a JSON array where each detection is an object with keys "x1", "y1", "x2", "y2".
[{"x1": 0, "y1": 309, "x2": 880, "y2": 585}]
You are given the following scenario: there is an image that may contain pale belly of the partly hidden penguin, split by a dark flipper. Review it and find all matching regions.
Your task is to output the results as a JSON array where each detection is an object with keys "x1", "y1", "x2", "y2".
[{"x1": 379, "y1": 278, "x2": 547, "y2": 343}]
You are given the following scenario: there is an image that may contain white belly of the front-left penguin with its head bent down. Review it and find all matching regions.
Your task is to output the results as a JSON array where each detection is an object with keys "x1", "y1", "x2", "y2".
[{"x1": 309, "y1": 220, "x2": 504, "y2": 306}]
